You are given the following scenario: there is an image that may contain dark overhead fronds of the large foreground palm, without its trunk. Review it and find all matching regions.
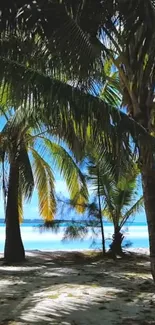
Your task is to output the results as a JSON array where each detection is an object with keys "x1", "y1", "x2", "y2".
[{"x1": 0, "y1": 1, "x2": 154, "y2": 204}]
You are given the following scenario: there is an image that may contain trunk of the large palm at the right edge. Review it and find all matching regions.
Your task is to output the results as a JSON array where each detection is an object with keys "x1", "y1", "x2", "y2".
[{"x1": 142, "y1": 164, "x2": 155, "y2": 282}]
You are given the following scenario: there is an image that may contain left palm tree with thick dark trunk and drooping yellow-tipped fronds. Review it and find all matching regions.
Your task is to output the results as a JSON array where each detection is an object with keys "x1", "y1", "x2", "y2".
[{"x1": 0, "y1": 109, "x2": 87, "y2": 263}]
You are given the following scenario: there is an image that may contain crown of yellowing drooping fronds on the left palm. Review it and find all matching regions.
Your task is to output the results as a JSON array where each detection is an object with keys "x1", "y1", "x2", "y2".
[{"x1": 0, "y1": 108, "x2": 88, "y2": 221}]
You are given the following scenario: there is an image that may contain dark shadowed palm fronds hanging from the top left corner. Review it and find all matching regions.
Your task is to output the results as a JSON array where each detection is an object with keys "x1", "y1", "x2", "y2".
[{"x1": 0, "y1": 0, "x2": 112, "y2": 78}]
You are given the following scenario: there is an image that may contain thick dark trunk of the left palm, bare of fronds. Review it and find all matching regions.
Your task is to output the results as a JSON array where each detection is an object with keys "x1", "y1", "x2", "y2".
[{"x1": 4, "y1": 162, "x2": 25, "y2": 263}]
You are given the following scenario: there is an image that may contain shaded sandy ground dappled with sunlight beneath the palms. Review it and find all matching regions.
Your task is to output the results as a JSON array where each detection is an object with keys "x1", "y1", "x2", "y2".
[{"x1": 0, "y1": 249, "x2": 155, "y2": 325}]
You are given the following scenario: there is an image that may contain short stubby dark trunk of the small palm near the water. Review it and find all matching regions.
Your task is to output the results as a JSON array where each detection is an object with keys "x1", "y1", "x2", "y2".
[{"x1": 110, "y1": 226, "x2": 124, "y2": 256}]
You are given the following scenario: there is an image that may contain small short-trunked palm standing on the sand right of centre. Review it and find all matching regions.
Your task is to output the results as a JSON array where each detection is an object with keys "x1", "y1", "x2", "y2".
[{"x1": 102, "y1": 176, "x2": 143, "y2": 255}]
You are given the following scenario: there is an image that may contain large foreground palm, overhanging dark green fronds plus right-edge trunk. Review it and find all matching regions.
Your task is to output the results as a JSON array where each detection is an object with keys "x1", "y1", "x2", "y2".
[{"x1": 0, "y1": 0, "x2": 155, "y2": 279}]
